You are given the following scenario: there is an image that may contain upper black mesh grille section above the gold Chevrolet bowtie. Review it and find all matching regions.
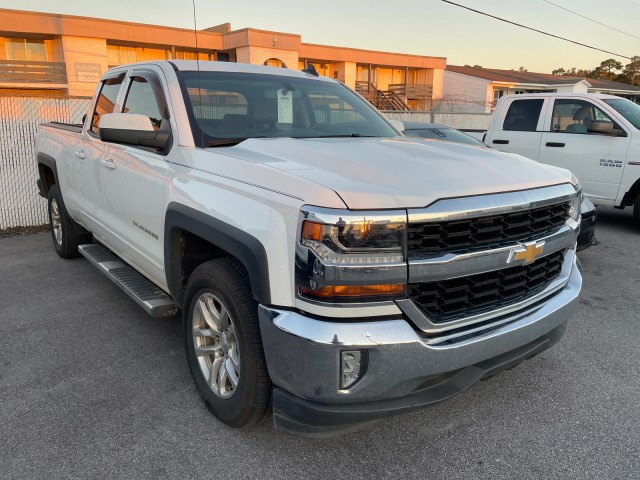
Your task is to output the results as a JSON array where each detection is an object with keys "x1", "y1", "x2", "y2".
[{"x1": 408, "y1": 202, "x2": 571, "y2": 259}]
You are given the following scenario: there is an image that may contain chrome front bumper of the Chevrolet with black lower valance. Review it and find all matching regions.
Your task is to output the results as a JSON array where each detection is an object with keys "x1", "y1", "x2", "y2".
[{"x1": 259, "y1": 257, "x2": 582, "y2": 436}]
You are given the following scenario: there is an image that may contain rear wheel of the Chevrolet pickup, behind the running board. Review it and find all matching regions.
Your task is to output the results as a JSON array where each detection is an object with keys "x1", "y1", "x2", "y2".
[{"x1": 47, "y1": 184, "x2": 92, "y2": 258}]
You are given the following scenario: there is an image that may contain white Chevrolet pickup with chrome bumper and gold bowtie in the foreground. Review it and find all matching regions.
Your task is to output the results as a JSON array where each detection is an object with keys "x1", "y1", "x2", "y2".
[{"x1": 37, "y1": 61, "x2": 582, "y2": 437}]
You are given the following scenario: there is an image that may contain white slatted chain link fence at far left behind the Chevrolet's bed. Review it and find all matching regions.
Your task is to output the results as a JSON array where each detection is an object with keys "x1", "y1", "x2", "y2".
[{"x1": 0, "y1": 97, "x2": 89, "y2": 230}]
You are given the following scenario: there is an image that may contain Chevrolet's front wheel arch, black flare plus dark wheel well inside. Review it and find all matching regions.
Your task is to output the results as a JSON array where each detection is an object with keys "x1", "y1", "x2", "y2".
[{"x1": 164, "y1": 202, "x2": 271, "y2": 305}]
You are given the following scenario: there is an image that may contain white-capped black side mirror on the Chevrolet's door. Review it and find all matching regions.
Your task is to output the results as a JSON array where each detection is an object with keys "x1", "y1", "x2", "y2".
[{"x1": 98, "y1": 113, "x2": 171, "y2": 150}]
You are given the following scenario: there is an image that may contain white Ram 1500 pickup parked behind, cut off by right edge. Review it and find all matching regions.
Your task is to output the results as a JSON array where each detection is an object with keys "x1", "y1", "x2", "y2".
[{"x1": 484, "y1": 93, "x2": 640, "y2": 221}]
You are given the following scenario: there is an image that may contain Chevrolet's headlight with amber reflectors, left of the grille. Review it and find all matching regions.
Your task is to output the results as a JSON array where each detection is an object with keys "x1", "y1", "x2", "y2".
[{"x1": 296, "y1": 207, "x2": 407, "y2": 303}]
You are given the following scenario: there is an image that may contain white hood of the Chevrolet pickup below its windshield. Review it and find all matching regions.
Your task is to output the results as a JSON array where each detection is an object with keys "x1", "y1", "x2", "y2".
[{"x1": 225, "y1": 137, "x2": 571, "y2": 209}]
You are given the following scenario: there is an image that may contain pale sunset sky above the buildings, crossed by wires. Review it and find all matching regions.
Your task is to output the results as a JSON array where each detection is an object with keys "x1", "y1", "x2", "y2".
[{"x1": 0, "y1": 0, "x2": 640, "y2": 73}]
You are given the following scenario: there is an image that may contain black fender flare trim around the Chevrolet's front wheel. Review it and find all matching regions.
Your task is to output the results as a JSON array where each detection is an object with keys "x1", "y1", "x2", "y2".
[{"x1": 164, "y1": 202, "x2": 271, "y2": 305}]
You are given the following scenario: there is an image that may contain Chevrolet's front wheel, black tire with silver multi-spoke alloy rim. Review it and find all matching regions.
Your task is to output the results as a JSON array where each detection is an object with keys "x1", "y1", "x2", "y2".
[{"x1": 182, "y1": 258, "x2": 271, "y2": 428}]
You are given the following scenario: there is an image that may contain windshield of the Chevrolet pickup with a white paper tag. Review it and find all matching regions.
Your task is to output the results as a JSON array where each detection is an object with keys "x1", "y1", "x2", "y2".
[{"x1": 178, "y1": 72, "x2": 398, "y2": 147}]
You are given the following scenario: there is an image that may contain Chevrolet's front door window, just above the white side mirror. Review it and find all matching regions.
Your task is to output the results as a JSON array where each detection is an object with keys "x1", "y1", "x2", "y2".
[{"x1": 122, "y1": 72, "x2": 169, "y2": 130}]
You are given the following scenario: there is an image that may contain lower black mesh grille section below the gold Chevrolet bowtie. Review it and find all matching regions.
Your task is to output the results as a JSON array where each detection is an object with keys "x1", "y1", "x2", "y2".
[{"x1": 409, "y1": 251, "x2": 564, "y2": 323}]
